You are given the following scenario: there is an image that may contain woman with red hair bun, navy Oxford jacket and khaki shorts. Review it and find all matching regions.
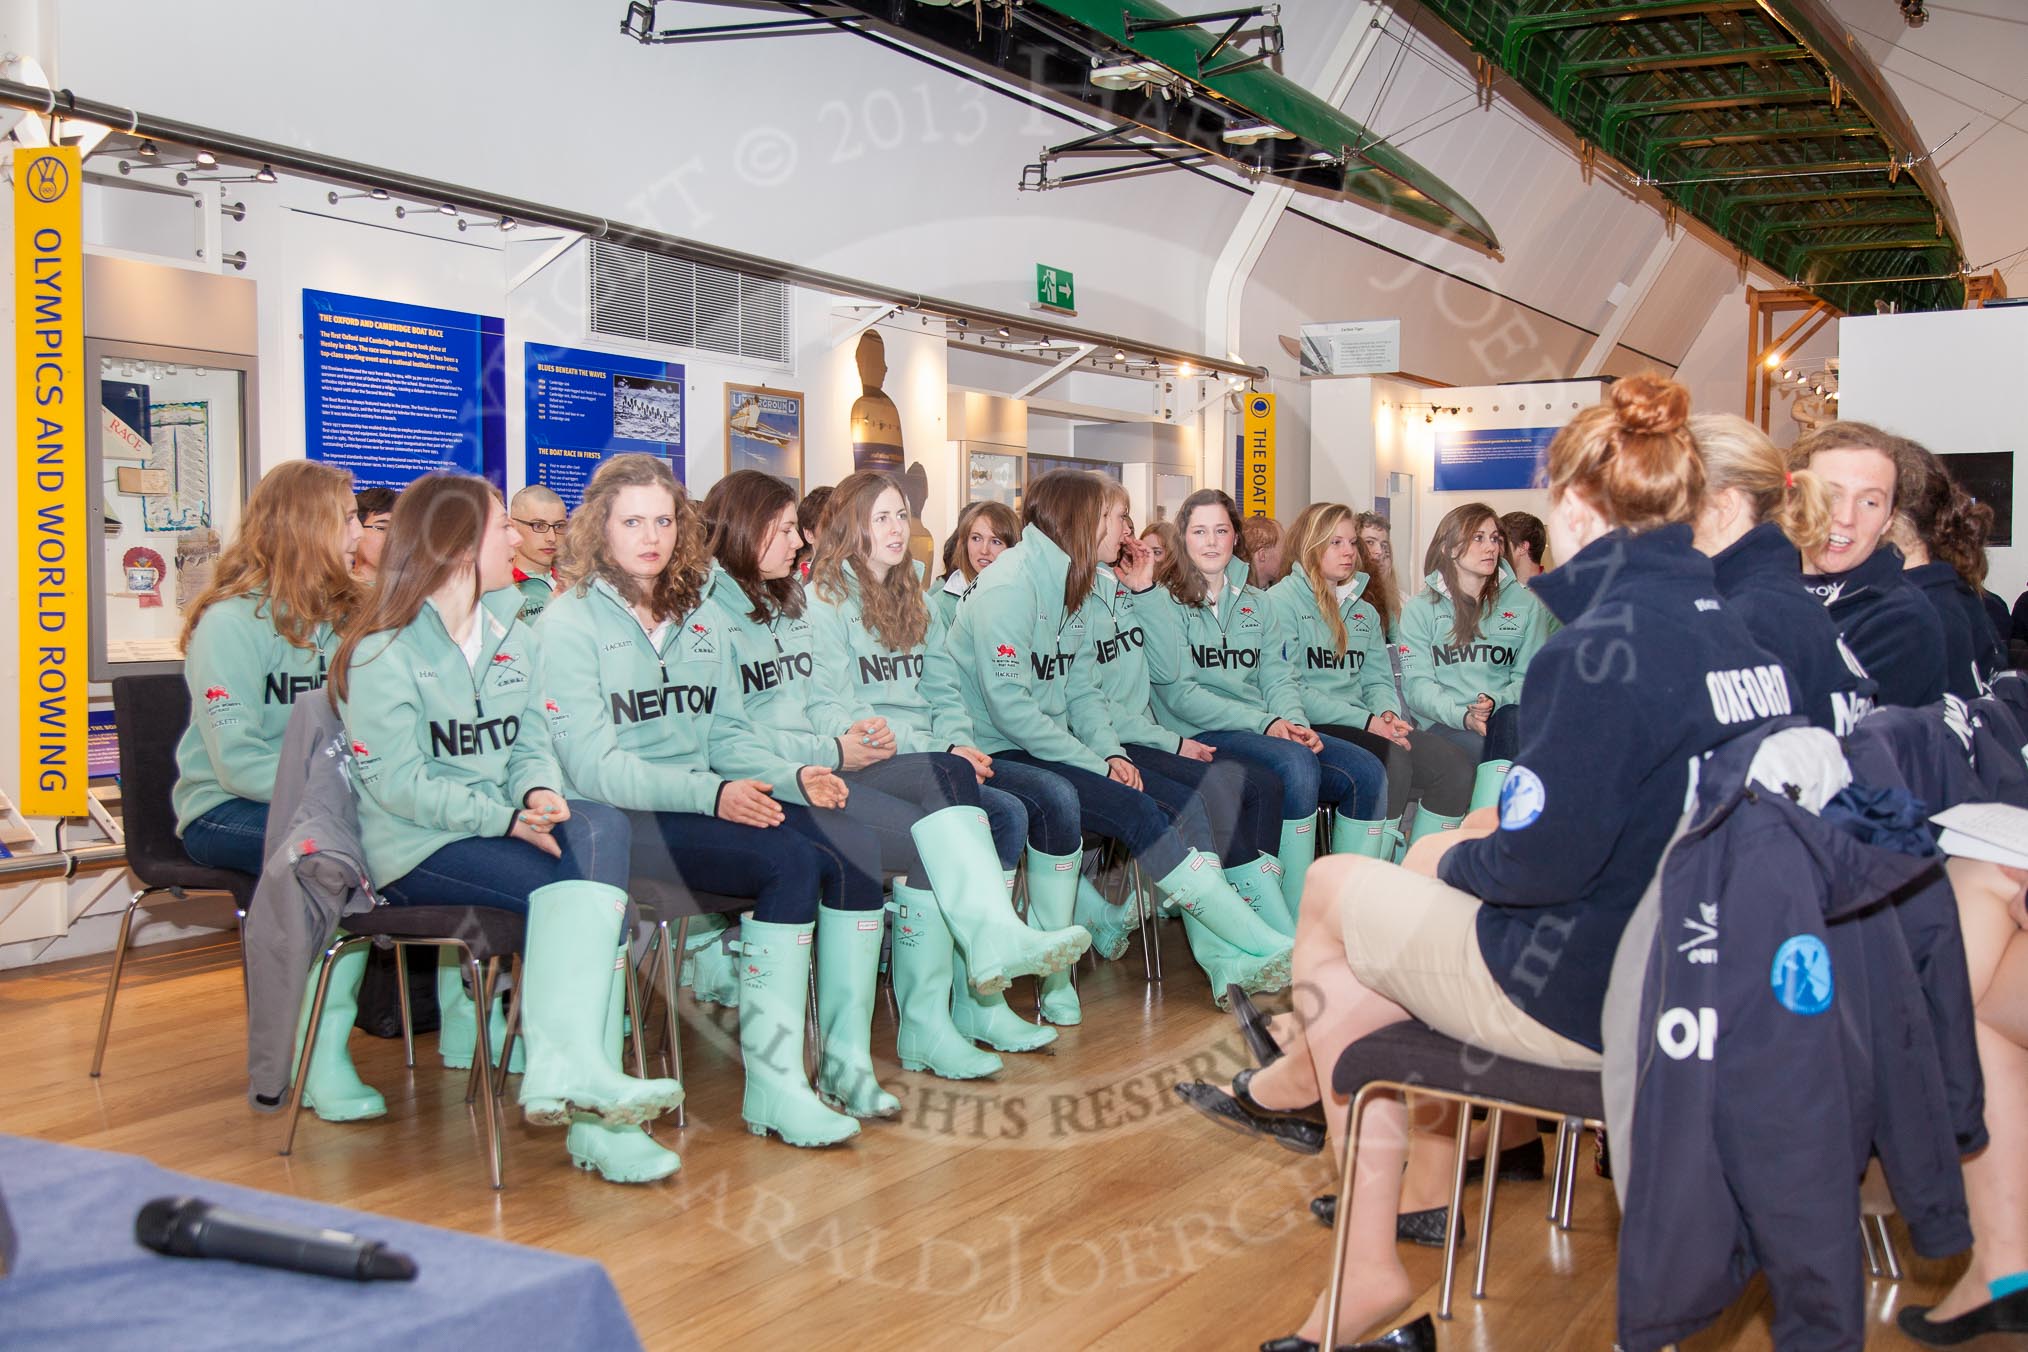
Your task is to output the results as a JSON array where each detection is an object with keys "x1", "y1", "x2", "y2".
[{"x1": 1200, "y1": 377, "x2": 1793, "y2": 1348}]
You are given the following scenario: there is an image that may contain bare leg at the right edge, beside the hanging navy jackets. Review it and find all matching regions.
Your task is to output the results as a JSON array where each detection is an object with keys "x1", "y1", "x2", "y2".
[{"x1": 1931, "y1": 859, "x2": 2028, "y2": 1320}]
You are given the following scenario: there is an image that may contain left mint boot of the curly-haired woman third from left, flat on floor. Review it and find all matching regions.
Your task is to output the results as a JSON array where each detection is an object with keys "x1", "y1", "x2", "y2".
[{"x1": 740, "y1": 920, "x2": 855, "y2": 1145}]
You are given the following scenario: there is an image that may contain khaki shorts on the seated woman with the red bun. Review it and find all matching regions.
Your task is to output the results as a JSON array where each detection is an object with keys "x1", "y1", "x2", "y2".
[{"x1": 1338, "y1": 868, "x2": 1602, "y2": 1070}]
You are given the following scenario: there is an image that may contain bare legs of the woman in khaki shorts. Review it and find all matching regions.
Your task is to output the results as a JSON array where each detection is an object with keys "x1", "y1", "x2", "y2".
[{"x1": 1253, "y1": 855, "x2": 1414, "y2": 1340}]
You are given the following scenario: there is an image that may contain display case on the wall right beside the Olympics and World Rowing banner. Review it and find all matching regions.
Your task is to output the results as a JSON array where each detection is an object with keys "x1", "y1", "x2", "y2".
[{"x1": 85, "y1": 339, "x2": 260, "y2": 681}]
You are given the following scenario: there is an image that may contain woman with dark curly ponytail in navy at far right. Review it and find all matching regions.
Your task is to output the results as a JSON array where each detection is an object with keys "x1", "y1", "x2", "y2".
[{"x1": 1888, "y1": 440, "x2": 2008, "y2": 699}]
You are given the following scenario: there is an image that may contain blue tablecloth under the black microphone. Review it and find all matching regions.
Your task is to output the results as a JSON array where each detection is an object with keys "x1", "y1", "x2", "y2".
[{"x1": 0, "y1": 1135, "x2": 641, "y2": 1352}]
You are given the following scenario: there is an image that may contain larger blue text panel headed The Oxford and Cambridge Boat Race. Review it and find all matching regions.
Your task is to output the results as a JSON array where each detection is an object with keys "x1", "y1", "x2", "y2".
[{"x1": 302, "y1": 290, "x2": 507, "y2": 491}]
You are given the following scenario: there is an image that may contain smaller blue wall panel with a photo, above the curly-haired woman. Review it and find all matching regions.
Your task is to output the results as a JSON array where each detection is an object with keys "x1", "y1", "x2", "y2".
[{"x1": 521, "y1": 343, "x2": 683, "y2": 511}]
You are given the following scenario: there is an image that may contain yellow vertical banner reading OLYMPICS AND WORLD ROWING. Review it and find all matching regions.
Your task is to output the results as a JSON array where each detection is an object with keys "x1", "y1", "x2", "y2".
[{"x1": 14, "y1": 146, "x2": 91, "y2": 817}]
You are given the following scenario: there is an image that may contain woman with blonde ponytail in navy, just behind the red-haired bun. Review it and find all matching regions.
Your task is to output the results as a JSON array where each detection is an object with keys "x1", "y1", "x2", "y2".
[{"x1": 1689, "y1": 414, "x2": 1874, "y2": 736}]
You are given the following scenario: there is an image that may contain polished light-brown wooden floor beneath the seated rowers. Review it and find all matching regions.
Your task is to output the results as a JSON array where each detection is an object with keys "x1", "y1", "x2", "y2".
[{"x1": 0, "y1": 926, "x2": 1963, "y2": 1352}]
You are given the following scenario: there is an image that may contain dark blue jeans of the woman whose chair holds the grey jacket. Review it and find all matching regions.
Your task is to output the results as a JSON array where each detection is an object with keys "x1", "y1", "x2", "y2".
[{"x1": 379, "y1": 799, "x2": 633, "y2": 914}]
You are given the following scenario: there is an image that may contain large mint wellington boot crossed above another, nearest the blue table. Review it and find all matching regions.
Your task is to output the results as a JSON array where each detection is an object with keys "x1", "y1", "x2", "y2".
[{"x1": 521, "y1": 880, "x2": 683, "y2": 1127}]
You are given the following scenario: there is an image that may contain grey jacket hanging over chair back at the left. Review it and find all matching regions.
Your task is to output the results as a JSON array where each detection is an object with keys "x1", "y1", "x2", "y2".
[{"x1": 245, "y1": 699, "x2": 379, "y2": 1113}]
